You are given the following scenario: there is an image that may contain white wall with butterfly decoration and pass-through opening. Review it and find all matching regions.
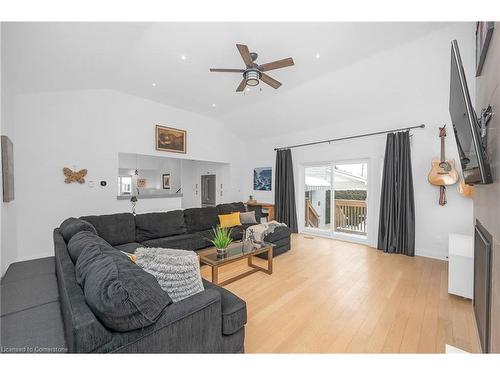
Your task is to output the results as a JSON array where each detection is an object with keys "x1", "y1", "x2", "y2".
[{"x1": 2, "y1": 90, "x2": 248, "y2": 270}]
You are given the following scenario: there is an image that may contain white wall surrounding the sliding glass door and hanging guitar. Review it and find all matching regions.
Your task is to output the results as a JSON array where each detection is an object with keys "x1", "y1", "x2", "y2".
[{"x1": 236, "y1": 23, "x2": 475, "y2": 258}]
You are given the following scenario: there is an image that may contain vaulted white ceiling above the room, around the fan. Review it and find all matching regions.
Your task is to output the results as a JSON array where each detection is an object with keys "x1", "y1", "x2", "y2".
[{"x1": 2, "y1": 23, "x2": 468, "y2": 135}]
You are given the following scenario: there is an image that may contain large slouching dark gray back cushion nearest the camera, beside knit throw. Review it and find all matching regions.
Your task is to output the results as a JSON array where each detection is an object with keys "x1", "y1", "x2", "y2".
[{"x1": 75, "y1": 236, "x2": 172, "y2": 332}]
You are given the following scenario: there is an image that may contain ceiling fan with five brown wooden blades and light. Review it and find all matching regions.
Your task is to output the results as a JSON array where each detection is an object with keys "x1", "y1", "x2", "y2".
[{"x1": 210, "y1": 44, "x2": 295, "y2": 91}]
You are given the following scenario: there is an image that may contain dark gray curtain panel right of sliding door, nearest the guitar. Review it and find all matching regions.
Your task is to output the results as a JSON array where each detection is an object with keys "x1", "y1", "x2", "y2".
[{"x1": 378, "y1": 131, "x2": 415, "y2": 256}]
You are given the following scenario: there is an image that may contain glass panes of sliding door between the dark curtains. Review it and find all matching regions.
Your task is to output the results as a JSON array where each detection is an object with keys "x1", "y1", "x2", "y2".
[{"x1": 304, "y1": 162, "x2": 368, "y2": 237}]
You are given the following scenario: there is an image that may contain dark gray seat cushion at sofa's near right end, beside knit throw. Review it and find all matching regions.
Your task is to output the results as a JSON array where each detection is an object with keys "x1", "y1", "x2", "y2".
[{"x1": 203, "y1": 280, "x2": 247, "y2": 335}]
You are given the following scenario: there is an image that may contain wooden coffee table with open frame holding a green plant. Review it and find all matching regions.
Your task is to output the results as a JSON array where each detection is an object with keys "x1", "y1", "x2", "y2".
[{"x1": 199, "y1": 242, "x2": 274, "y2": 286}]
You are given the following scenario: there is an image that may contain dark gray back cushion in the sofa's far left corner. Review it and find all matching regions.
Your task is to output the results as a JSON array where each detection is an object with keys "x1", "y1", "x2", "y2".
[{"x1": 80, "y1": 213, "x2": 136, "y2": 246}]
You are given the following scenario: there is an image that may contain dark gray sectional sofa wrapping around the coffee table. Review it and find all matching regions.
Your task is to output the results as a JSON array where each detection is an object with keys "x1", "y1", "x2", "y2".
[{"x1": 54, "y1": 202, "x2": 290, "y2": 353}]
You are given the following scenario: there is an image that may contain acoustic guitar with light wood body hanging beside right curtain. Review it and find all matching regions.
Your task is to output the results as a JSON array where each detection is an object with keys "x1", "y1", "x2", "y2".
[{"x1": 427, "y1": 125, "x2": 458, "y2": 206}]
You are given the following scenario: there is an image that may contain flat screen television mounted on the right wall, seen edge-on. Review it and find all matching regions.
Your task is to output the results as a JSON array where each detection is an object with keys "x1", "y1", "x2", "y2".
[{"x1": 450, "y1": 40, "x2": 493, "y2": 185}]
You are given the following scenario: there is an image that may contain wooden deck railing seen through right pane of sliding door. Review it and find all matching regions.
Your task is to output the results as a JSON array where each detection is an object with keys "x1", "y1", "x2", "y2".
[{"x1": 334, "y1": 199, "x2": 366, "y2": 234}]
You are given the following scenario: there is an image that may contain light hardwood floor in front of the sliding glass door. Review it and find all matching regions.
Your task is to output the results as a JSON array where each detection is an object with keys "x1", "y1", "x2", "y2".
[{"x1": 202, "y1": 234, "x2": 479, "y2": 353}]
